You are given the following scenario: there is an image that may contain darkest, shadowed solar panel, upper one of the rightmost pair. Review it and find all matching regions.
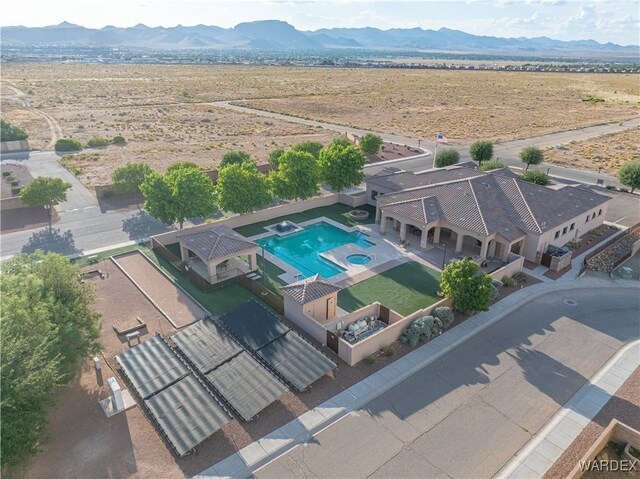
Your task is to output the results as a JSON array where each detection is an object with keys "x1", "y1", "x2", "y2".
[{"x1": 220, "y1": 300, "x2": 289, "y2": 350}]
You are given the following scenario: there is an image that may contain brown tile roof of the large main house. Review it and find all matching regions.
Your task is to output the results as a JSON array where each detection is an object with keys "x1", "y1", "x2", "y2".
[{"x1": 378, "y1": 170, "x2": 610, "y2": 241}]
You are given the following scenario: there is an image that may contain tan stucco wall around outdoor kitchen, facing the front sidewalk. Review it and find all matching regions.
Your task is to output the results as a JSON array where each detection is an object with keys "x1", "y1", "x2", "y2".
[{"x1": 338, "y1": 299, "x2": 453, "y2": 366}]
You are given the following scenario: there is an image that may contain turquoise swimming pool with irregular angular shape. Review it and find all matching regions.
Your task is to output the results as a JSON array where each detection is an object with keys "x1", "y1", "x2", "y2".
[{"x1": 256, "y1": 221, "x2": 373, "y2": 278}]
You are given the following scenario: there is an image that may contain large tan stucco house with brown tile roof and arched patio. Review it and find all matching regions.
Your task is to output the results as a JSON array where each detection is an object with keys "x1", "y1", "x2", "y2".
[{"x1": 366, "y1": 165, "x2": 611, "y2": 263}]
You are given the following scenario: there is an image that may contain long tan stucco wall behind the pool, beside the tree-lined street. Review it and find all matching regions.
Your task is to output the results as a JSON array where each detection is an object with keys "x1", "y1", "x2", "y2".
[{"x1": 153, "y1": 193, "x2": 340, "y2": 245}]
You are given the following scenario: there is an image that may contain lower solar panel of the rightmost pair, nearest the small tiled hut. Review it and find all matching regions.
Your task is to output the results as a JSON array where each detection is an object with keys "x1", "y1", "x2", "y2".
[{"x1": 257, "y1": 331, "x2": 337, "y2": 391}]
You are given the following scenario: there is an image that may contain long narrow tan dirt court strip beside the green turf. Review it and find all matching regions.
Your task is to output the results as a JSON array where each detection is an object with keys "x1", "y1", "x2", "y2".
[{"x1": 114, "y1": 251, "x2": 209, "y2": 328}]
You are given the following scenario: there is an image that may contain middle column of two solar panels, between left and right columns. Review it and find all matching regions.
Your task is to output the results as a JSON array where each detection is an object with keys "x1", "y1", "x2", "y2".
[{"x1": 171, "y1": 318, "x2": 288, "y2": 421}]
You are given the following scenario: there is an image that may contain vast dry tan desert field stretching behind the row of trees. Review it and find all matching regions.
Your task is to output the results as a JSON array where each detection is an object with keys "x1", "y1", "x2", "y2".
[{"x1": 5, "y1": 63, "x2": 640, "y2": 185}]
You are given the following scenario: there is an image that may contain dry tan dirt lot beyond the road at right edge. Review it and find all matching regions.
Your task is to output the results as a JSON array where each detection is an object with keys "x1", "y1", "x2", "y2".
[{"x1": 544, "y1": 128, "x2": 640, "y2": 174}]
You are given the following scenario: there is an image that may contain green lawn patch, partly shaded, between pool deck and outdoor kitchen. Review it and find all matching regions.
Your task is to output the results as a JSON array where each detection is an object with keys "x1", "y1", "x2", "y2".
[{"x1": 338, "y1": 261, "x2": 440, "y2": 316}]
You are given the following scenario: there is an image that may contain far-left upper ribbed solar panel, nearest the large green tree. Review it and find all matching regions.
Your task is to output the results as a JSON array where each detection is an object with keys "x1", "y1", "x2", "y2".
[{"x1": 116, "y1": 336, "x2": 189, "y2": 399}]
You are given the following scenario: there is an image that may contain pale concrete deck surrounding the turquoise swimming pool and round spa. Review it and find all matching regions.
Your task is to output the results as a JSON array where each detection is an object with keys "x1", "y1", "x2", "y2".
[{"x1": 249, "y1": 216, "x2": 439, "y2": 287}]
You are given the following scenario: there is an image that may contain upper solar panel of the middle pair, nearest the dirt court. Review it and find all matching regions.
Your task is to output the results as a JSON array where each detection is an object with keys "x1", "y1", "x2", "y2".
[{"x1": 171, "y1": 318, "x2": 243, "y2": 374}]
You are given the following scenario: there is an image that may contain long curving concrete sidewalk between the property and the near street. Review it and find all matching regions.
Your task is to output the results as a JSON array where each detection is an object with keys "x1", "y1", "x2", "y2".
[{"x1": 196, "y1": 278, "x2": 640, "y2": 478}]
